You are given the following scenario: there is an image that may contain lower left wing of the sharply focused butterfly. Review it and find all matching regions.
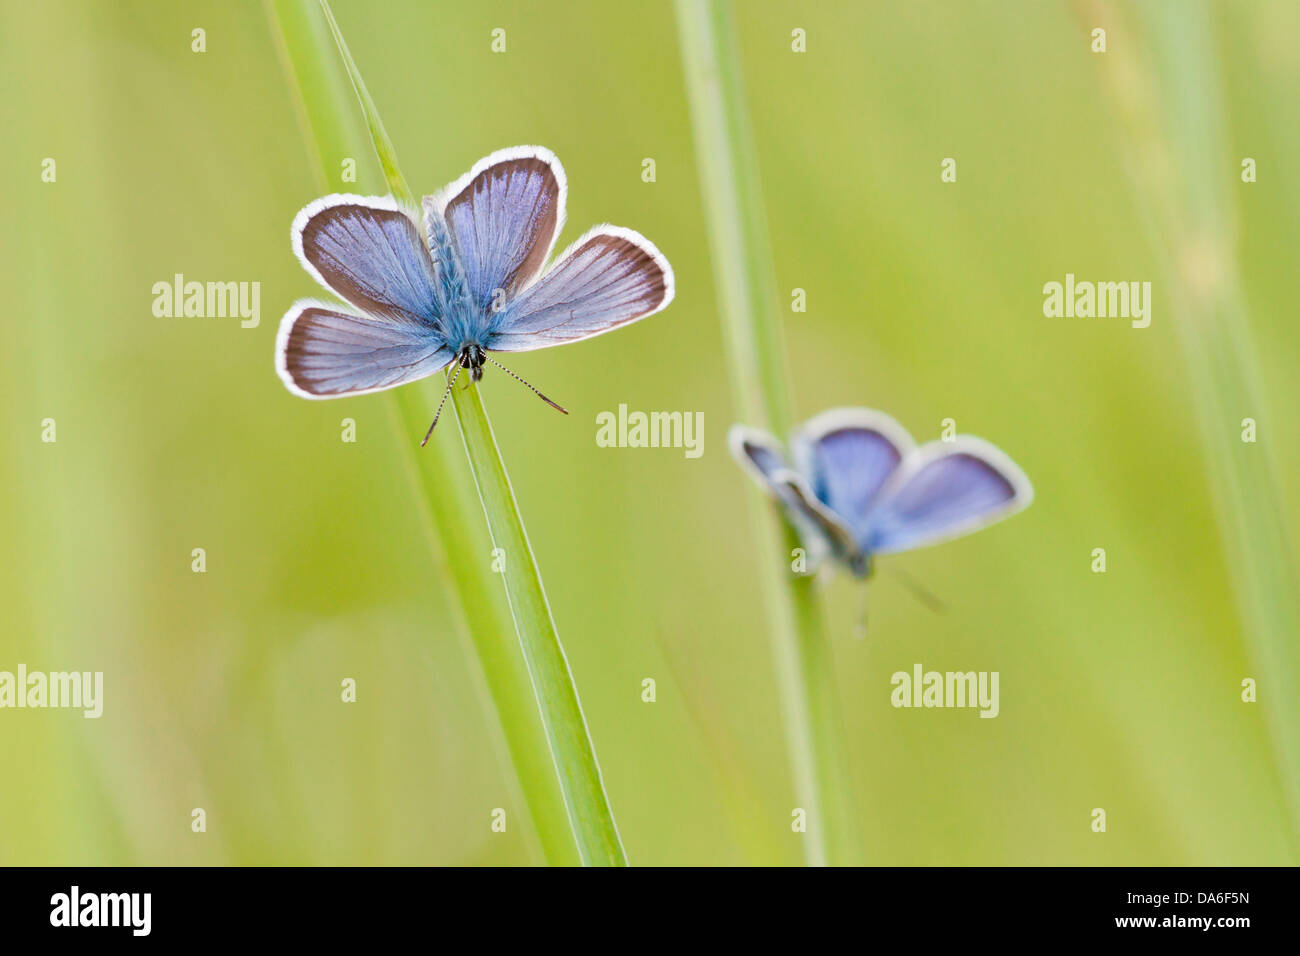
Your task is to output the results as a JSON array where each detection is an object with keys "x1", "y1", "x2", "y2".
[{"x1": 276, "y1": 299, "x2": 451, "y2": 398}]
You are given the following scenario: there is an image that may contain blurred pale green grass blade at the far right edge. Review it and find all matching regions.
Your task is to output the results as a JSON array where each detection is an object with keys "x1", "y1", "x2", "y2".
[{"x1": 1080, "y1": 0, "x2": 1300, "y2": 855}]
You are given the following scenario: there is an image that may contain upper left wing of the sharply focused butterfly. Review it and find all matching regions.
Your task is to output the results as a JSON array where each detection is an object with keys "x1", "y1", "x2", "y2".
[{"x1": 293, "y1": 195, "x2": 441, "y2": 329}]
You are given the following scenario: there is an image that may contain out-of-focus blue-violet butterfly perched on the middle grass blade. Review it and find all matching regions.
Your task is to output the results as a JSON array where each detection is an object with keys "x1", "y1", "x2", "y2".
[{"x1": 728, "y1": 408, "x2": 1034, "y2": 578}]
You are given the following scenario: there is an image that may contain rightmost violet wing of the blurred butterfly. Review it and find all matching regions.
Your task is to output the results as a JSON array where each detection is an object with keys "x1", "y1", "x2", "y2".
[{"x1": 866, "y1": 436, "x2": 1034, "y2": 554}]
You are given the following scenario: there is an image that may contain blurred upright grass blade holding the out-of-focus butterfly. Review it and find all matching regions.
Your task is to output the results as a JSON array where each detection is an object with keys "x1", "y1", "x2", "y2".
[{"x1": 677, "y1": 0, "x2": 859, "y2": 865}]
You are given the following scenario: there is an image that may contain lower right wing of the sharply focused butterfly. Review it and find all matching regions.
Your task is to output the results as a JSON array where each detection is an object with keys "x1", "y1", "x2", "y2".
[{"x1": 485, "y1": 226, "x2": 673, "y2": 352}]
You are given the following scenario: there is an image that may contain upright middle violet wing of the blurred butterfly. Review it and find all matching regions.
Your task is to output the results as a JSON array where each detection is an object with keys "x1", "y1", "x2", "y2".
[{"x1": 790, "y1": 408, "x2": 915, "y2": 548}]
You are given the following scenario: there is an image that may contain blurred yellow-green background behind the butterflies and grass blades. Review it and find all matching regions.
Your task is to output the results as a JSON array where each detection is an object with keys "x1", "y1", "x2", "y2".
[{"x1": 0, "y1": 0, "x2": 1300, "y2": 865}]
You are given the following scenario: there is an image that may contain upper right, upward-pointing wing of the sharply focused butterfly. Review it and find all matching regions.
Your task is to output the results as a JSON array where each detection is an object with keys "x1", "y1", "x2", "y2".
[{"x1": 437, "y1": 146, "x2": 567, "y2": 313}]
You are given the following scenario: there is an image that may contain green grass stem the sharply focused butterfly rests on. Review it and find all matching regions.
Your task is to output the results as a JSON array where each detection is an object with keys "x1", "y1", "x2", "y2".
[{"x1": 269, "y1": 0, "x2": 627, "y2": 865}]
